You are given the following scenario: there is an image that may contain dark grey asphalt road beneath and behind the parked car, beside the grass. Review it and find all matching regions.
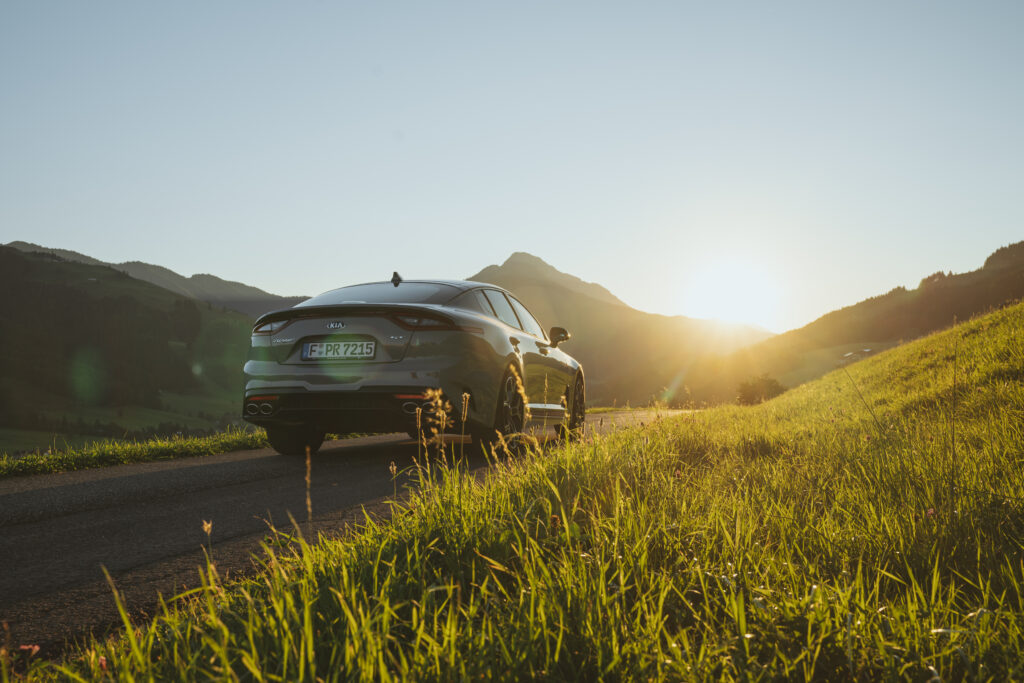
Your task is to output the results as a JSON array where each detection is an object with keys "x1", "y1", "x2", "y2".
[{"x1": 0, "y1": 411, "x2": 671, "y2": 654}]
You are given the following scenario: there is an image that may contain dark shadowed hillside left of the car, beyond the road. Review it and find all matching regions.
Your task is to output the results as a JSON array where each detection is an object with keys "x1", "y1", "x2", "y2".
[{"x1": 0, "y1": 247, "x2": 251, "y2": 451}]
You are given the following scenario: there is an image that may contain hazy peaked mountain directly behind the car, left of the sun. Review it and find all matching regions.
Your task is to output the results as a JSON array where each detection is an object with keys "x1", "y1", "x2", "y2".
[{"x1": 468, "y1": 252, "x2": 770, "y2": 404}]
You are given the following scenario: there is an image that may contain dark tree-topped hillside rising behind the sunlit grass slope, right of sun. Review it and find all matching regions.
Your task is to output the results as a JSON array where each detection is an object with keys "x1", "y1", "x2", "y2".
[{"x1": 683, "y1": 242, "x2": 1024, "y2": 402}]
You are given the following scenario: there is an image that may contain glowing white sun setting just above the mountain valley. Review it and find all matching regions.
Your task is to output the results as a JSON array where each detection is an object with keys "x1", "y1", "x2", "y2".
[{"x1": 680, "y1": 258, "x2": 782, "y2": 332}]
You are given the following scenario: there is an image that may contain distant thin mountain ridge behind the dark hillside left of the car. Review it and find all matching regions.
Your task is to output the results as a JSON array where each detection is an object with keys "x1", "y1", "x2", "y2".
[{"x1": 6, "y1": 242, "x2": 307, "y2": 317}]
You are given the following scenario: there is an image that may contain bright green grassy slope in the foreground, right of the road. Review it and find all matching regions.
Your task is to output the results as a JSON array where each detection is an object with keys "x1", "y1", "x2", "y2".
[{"x1": 9, "y1": 305, "x2": 1024, "y2": 681}]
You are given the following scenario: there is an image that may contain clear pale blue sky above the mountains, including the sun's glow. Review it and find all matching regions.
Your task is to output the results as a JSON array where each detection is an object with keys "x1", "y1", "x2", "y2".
[{"x1": 0, "y1": 0, "x2": 1024, "y2": 331}]
